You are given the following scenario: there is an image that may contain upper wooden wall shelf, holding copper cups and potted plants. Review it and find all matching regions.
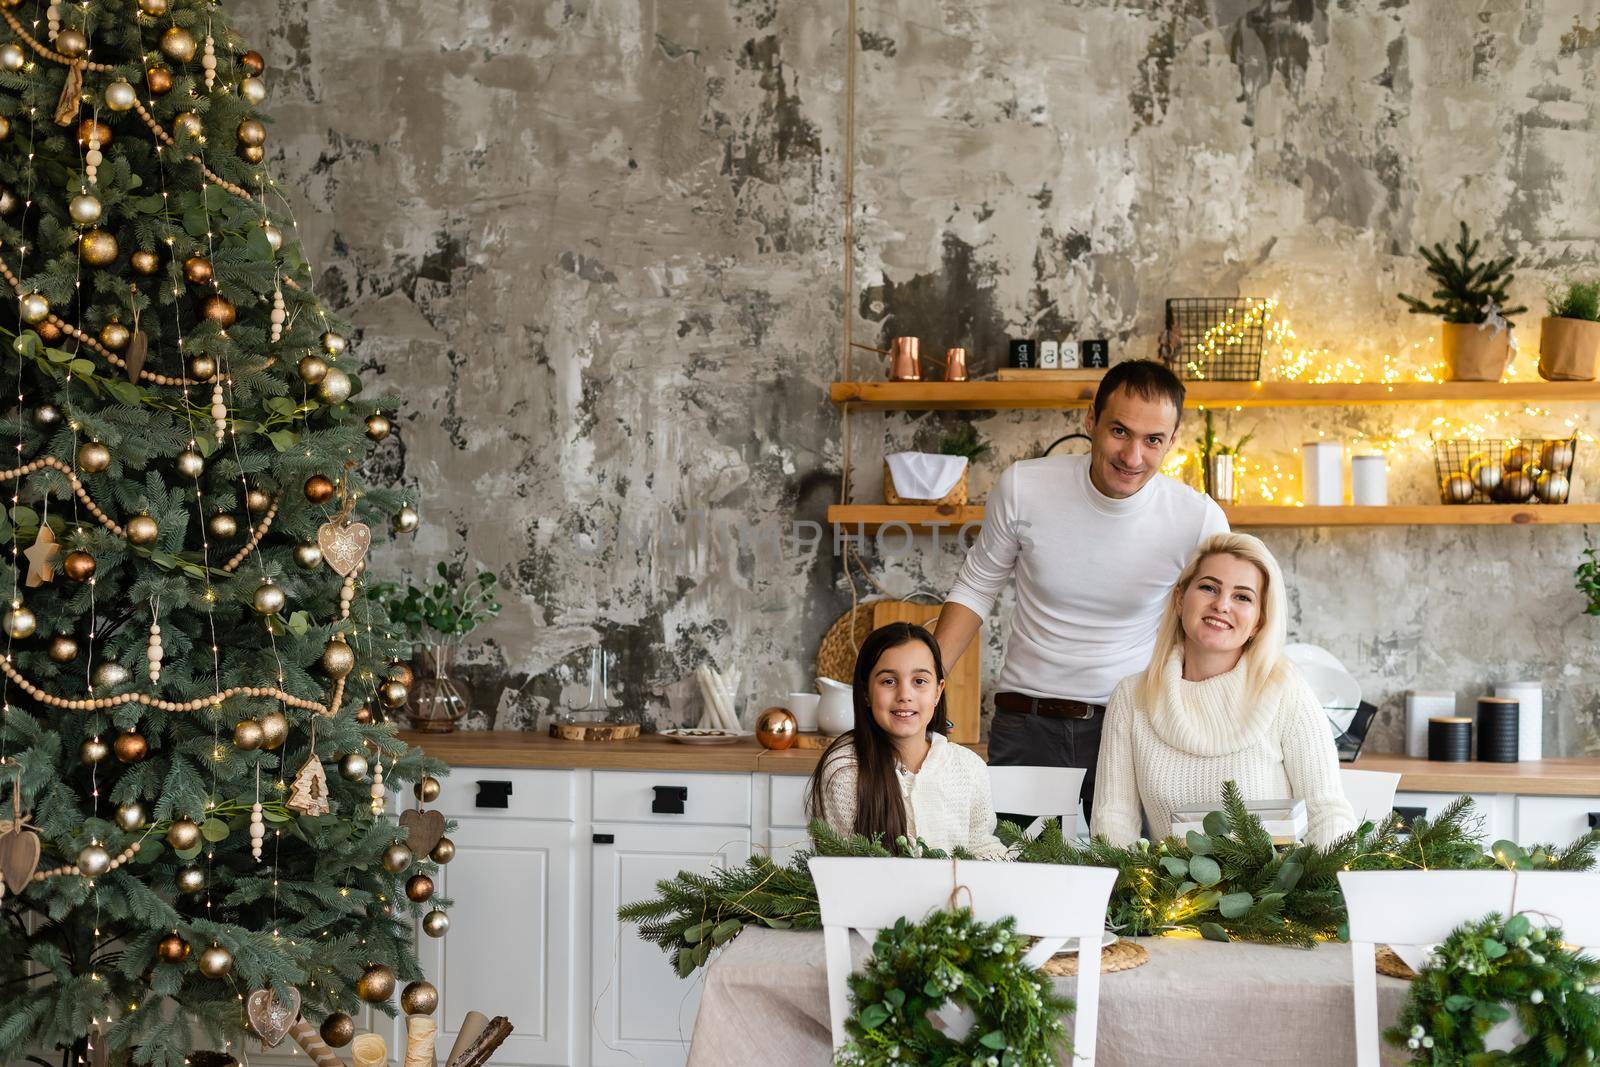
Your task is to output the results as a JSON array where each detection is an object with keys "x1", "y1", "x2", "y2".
[{"x1": 829, "y1": 381, "x2": 1600, "y2": 411}]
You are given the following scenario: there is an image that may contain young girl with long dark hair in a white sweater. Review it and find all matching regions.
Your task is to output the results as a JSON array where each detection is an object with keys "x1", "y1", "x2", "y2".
[{"x1": 810, "y1": 622, "x2": 1005, "y2": 859}]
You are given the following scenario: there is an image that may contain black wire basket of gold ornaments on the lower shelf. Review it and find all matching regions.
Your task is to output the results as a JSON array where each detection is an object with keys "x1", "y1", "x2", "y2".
[{"x1": 1434, "y1": 437, "x2": 1578, "y2": 504}]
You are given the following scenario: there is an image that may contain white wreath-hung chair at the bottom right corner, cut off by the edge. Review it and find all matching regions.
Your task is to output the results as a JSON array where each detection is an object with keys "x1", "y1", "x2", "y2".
[{"x1": 1339, "y1": 870, "x2": 1600, "y2": 1067}]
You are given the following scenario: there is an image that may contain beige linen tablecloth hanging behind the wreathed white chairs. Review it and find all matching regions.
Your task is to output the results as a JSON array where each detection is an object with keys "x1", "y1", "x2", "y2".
[{"x1": 690, "y1": 929, "x2": 1406, "y2": 1067}]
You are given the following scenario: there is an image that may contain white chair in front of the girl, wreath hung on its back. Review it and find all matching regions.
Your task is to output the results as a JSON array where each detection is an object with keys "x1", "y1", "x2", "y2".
[{"x1": 811, "y1": 856, "x2": 1117, "y2": 1065}]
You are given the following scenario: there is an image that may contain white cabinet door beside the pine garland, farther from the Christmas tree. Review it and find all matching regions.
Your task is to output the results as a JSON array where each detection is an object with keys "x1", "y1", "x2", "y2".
[{"x1": 590, "y1": 822, "x2": 750, "y2": 1067}]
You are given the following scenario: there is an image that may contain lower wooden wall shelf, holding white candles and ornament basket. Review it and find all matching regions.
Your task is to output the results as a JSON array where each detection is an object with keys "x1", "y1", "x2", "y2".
[{"x1": 827, "y1": 504, "x2": 1600, "y2": 534}]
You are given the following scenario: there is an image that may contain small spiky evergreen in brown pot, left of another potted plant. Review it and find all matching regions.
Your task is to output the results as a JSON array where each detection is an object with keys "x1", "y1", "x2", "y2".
[{"x1": 1400, "y1": 222, "x2": 1528, "y2": 382}]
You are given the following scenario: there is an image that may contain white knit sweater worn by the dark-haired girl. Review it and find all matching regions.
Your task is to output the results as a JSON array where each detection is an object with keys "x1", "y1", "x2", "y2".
[{"x1": 814, "y1": 734, "x2": 1005, "y2": 859}]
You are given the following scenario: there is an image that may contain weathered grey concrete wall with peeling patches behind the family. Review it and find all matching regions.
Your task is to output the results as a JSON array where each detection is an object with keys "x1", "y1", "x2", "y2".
[{"x1": 237, "y1": 0, "x2": 1600, "y2": 753}]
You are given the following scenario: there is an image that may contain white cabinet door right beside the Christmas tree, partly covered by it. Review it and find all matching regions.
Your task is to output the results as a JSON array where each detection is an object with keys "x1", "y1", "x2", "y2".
[{"x1": 422, "y1": 816, "x2": 576, "y2": 1067}]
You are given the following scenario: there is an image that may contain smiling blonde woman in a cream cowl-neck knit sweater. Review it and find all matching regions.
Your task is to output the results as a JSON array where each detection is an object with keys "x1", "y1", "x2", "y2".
[{"x1": 1093, "y1": 533, "x2": 1355, "y2": 846}]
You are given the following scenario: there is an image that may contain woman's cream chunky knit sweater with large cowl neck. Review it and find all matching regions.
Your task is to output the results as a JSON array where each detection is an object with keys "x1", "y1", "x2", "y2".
[{"x1": 1093, "y1": 651, "x2": 1355, "y2": 845}]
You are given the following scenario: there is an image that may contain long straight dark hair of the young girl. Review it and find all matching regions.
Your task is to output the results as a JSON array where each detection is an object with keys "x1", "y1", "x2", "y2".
[{"x1": 808, "y1": 622, "x2": 950, "y2": 849}]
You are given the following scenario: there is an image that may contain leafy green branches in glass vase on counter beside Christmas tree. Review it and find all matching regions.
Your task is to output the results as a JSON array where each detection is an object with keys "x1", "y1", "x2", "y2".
[{"x1": 373, "y1": 563, "x2": 501, "y2": 733}]
